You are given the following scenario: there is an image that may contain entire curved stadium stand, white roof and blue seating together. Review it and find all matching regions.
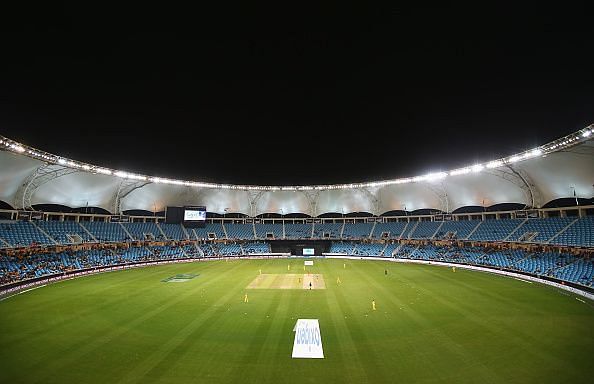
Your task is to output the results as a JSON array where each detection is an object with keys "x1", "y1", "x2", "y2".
[{"x1": 0, "y1": 125, "x2": 594, "y2": 287}]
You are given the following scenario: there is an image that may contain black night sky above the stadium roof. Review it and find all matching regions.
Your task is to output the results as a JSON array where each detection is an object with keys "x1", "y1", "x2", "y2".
[{"x1": 0, "y1": 2, "x2": 594, "y2": 185}]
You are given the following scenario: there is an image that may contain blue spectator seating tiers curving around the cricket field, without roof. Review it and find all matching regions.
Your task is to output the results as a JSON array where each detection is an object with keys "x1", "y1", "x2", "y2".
[{"x1": 0, "y1": 216, "x2": 594, "y2": 286}]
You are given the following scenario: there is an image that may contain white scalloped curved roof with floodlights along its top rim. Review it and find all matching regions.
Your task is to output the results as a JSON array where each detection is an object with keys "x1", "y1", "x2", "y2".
[{"x1": 0, "y1": 125, "x2": 594, "y2": 216}]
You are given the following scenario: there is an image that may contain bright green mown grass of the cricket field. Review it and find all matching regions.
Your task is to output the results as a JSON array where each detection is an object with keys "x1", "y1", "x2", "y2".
[{"x1": 0, "y1": 259, "x2": 594, "y2": 384}]
